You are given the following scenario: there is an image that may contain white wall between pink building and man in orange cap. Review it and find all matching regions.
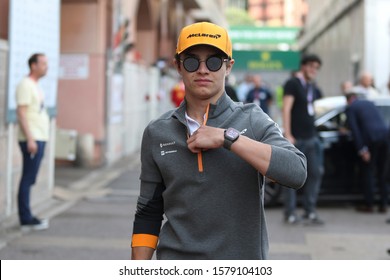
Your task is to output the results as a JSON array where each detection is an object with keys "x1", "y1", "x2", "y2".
[{"x1": 106, "y1": 63, "x2": 174, "y2": 164}]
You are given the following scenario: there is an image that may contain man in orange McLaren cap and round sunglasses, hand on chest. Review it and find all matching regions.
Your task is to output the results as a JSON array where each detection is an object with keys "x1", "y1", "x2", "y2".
[{"x1": 132, "y1": 22, "x2": 306, "y2": 260}]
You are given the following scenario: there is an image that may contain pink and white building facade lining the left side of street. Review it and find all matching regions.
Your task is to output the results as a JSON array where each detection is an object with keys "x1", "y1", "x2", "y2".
[{"x1": 0, "y1": 0, "x2": 227, "y2": 225}]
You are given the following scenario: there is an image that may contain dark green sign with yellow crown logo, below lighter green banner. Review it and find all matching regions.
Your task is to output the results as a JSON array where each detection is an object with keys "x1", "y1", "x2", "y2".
[{"x1": 233, "y1": 51, "x2": 300, "y2": 71}]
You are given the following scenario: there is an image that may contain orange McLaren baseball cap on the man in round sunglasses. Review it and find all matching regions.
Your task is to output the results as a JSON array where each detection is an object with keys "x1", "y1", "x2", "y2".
[{"x1": 176, "y1": 22, "x2": 232, "y2": 58}]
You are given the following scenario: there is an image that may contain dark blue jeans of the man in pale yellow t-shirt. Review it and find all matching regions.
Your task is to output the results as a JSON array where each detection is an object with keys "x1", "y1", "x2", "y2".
[{"x1": 18, "y1": 141, "x2": 46, "y2": 224}]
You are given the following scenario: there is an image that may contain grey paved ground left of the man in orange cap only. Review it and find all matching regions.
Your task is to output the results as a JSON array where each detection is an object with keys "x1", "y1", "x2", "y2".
[{"x1": 0, "y1": 154, "x2": 139, "y2": 260}]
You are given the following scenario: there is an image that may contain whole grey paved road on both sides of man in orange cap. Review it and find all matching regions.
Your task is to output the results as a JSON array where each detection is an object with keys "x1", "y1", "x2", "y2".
[{"x1": 0, "y1": 154, "x2": 390, "y2": 260}]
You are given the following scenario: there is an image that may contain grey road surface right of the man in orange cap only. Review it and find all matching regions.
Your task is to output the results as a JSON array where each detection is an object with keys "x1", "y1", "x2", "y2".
[{"x1": 267, "y1": 206, "x2": 390, "y2": 260}]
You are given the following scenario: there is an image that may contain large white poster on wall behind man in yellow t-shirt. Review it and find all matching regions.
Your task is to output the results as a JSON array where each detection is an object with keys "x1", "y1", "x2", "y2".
[{"x1": 7, "y1": 0, "x2": 60, "y2": 122}]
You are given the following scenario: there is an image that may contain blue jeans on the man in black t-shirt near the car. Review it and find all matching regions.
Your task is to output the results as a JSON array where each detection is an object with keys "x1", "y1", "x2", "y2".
[{"x1": 284, "y1": 137, "x2": 324, "y2": 216}]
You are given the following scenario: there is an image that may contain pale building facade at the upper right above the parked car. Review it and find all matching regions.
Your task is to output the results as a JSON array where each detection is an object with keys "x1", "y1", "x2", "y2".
[{"x1": 299, "y1": 0, "x2": 390, "y2": 96}]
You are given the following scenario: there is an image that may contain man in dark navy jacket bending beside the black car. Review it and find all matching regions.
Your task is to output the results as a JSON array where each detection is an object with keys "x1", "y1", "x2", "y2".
[{"x1": 346, "y1": 89, "x2": 388, "y2": 213}]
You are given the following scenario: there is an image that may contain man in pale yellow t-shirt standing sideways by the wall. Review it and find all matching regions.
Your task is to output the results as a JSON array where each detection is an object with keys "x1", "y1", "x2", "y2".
[{"x1": 16, "y1": 53, "x2": 49, "y2": 230}]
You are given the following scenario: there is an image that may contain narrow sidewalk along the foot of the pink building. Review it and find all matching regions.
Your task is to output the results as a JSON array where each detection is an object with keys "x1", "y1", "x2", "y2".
[{"x1": 0, "y1": 153, "x2": 139, "y2": 253}]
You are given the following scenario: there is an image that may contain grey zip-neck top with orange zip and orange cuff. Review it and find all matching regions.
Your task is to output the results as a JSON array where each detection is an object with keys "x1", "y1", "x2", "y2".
[{"x1": 132, "y1": 94, "x2": 306, "y2": 260}]
